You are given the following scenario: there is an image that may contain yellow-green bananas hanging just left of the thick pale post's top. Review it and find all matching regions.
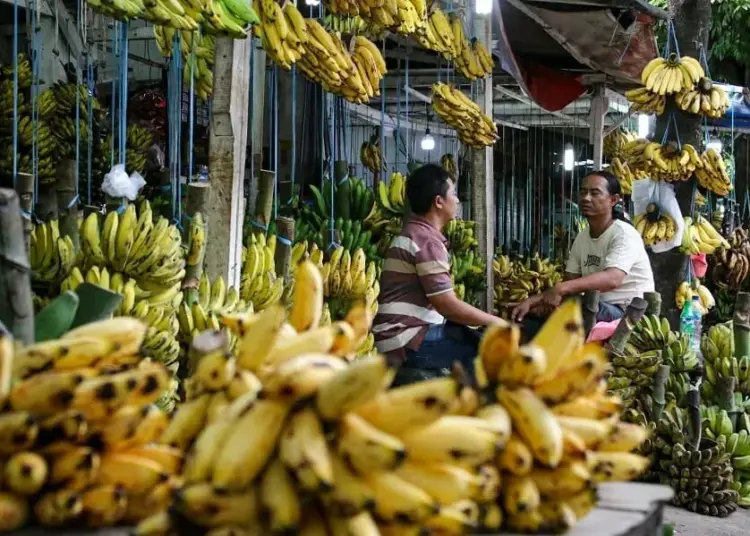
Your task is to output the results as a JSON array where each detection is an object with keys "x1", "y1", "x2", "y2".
[{"x1": 154, "y1": 24, "x2": 216, "y2": 102}]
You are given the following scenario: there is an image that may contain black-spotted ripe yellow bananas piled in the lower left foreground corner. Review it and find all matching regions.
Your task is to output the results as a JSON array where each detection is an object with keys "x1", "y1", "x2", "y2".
[{"x1": 0, "y1": 318, "x2": 188, "y2": 531}]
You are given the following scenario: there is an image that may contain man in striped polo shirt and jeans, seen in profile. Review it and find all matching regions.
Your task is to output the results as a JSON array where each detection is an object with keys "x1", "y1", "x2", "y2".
[{"x1": 373, "y1": 164, "x2": 503, "y2": 385}]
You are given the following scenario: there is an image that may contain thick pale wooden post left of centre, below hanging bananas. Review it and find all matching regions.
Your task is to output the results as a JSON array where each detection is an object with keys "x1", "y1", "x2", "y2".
[{"x1": 206, "y1": 37, "x2": 255, "y2": 287}]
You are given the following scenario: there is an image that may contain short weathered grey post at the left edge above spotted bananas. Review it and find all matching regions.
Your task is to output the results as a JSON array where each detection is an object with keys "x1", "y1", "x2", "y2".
[{"x1": 0, "y1": 189, "x2": 34, "y2": 344}]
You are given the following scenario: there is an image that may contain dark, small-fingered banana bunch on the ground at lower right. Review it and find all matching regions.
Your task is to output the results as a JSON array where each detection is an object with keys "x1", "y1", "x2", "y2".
[{"x1": 642, "y1": 405, "x2": 739, "y2": 517}]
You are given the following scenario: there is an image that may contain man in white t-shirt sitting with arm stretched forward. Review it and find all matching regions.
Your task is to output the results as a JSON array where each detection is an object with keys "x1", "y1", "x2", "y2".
[{"x1": 511, "y1": 171, "x2": 654, "y2": 322}]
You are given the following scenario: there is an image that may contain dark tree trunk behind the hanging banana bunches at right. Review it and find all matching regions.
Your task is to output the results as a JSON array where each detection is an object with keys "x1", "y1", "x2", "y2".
[{"x1": 649, "y1": 0, "x2": 711, "y2": 329}]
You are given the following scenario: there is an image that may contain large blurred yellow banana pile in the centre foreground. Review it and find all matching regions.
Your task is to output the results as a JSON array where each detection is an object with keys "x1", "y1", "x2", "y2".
[{"x1": 135, "y1": 280, "x2": 648, "y2": 536}]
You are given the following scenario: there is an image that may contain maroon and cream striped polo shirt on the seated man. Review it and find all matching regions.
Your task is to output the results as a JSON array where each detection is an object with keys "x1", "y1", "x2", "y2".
[{"x1": 372, "y1": 215, "x2": 453, "y2": 358}]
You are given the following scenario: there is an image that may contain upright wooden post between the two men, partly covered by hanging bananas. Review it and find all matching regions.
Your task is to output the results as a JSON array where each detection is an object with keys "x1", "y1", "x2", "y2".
[{"x1": 471, "y1": 16, "x2": 497, "y2": 313}]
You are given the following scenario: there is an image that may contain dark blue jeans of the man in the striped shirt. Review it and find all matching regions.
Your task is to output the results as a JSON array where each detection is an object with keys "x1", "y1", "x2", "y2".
[{"x1": 393, "y1": 324, "x2": 477, "y2": 386}]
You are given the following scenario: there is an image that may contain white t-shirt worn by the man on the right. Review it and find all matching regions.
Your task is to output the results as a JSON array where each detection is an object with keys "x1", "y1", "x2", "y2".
[{"x1": 565, "y1": 220, "x2": 654, "y2": 307}]
